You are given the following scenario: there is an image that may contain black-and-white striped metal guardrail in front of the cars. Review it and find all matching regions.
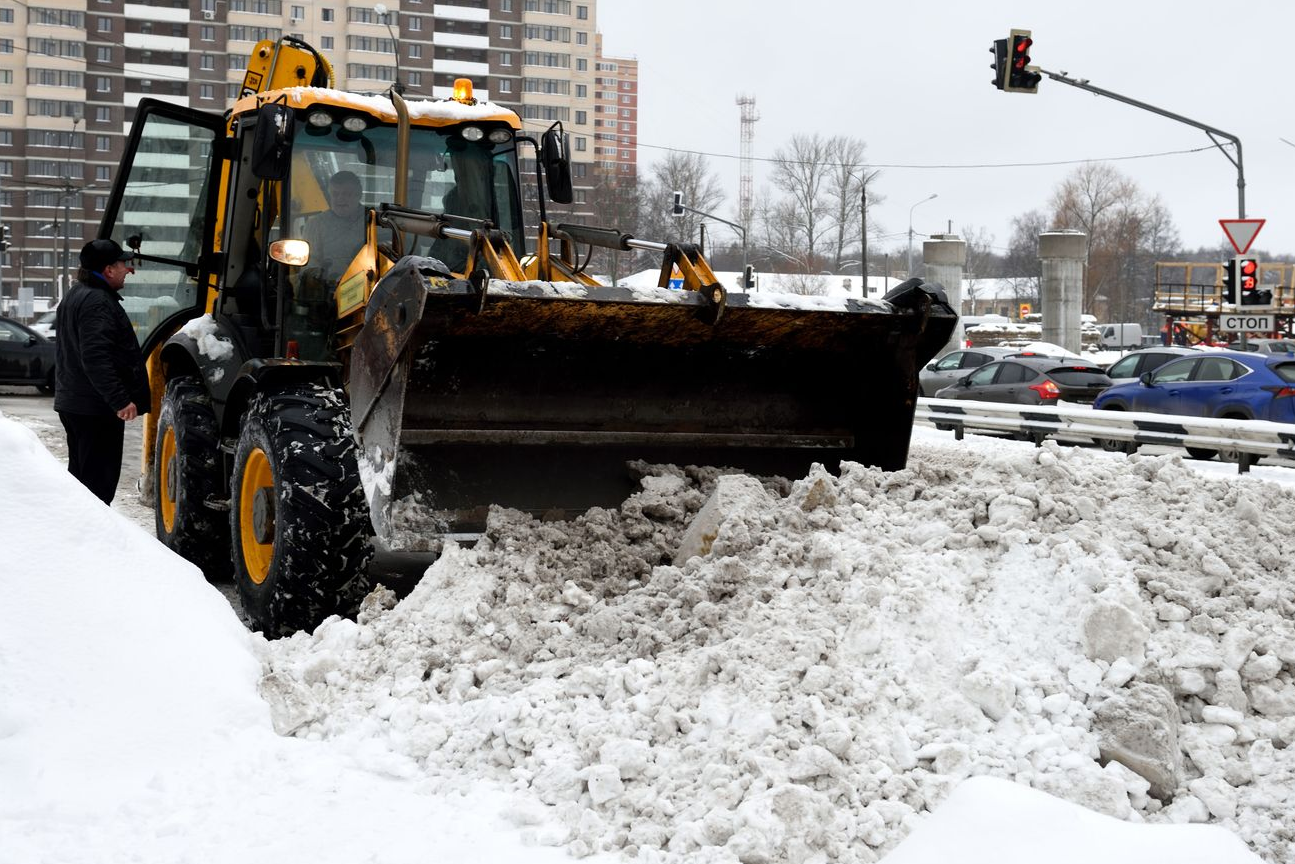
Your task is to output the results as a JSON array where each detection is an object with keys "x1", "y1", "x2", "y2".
[{"x1": 913, "y1": 398, "x2": 1295, "y2": 474}]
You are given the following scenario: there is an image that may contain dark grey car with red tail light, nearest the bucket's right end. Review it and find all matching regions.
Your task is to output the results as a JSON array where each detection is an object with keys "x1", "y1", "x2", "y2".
[{"x1": 935, "y1": 356, "x2": 1111, "y2": 405}]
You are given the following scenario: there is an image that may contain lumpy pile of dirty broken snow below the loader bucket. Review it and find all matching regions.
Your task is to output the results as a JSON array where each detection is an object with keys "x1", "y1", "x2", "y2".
[{"x1": 262, "y1": 443, "x2": 1295, "y2": 864}]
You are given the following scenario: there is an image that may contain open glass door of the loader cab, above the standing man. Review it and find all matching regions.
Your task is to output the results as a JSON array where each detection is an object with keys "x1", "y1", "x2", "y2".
[{"x1": 98, "y1": 98, "x2": 225, "y2": 355}]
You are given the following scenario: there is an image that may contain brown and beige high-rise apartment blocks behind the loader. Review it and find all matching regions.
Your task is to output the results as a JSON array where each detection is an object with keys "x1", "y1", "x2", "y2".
[{"x1": 0, "y1": 0, "x2": 637, "y2": 306}]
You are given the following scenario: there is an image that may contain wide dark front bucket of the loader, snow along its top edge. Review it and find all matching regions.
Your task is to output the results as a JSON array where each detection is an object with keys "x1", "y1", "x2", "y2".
[{"x1": 350, "y1": 259, "x2": 957, "y2": 548}]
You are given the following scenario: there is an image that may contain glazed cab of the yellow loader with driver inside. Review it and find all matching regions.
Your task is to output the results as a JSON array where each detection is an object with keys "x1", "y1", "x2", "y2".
[{"x1": 221, "y1": 100, "x2": 524, "y2": 360}]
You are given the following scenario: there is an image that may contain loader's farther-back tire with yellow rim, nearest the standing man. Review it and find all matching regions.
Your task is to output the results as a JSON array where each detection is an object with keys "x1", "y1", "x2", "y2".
[{"x1": 153, "y1": 377, "x2": 231, "y2": 582}]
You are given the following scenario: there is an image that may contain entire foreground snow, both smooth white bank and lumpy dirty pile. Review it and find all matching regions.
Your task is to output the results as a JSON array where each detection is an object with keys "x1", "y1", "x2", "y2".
[{"x1": 0, "y1": 396, "x2": 1295, "y2": 864}]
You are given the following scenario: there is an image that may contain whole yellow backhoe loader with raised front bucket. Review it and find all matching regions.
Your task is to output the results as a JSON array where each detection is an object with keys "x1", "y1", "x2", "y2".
[{"x1": 100, "y1": 38, "x2": 957, "y2": 633}]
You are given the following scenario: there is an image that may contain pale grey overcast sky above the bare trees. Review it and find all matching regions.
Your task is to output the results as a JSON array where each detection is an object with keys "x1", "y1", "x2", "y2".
[{"x1": 597, "y1": 0, "x2": 1295, "y2": 265}]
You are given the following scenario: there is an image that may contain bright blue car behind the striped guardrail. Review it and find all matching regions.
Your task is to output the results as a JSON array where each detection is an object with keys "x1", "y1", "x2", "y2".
[{"x1": 1093, "y1": 351, "x2": 1295, "y2": 459}]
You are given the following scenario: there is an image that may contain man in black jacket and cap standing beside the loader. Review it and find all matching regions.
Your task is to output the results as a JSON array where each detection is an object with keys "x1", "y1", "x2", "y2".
[{"x1": 54, "y1": 240, "x2": 152, "y2": 504}]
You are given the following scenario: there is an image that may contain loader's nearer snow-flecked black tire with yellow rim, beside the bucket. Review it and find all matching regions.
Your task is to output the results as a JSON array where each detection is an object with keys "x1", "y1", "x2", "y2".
[{"x1": 229, "y1": 385, "x2": 373, "y2": 637}]
